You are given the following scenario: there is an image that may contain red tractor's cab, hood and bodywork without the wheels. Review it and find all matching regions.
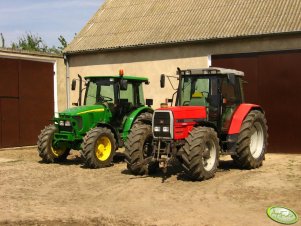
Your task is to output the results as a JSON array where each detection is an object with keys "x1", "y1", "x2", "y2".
[{"x1": 153, "y1": 68, "x2": 262, "y2": 152}]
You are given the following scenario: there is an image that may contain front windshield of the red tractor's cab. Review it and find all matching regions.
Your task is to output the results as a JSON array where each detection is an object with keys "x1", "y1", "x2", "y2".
[{"x1": 180, "y1": 77, "x2": 210, "y2": 106}]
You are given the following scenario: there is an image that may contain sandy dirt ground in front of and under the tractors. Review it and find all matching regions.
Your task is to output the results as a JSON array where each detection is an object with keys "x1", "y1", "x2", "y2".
[{"x1": 0, "y1": 148, "x2": 301, "y2": 226}]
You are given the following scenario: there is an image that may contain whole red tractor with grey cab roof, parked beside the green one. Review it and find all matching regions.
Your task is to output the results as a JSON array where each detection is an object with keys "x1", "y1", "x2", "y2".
[{"x1": 125, "y1": 67, "x2": 268, "y2": 180}]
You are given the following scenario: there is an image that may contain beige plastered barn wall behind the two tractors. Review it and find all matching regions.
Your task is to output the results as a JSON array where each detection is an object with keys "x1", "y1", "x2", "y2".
[{"x1": 70, "y1": 47, "x2": 208, "y2": 108}]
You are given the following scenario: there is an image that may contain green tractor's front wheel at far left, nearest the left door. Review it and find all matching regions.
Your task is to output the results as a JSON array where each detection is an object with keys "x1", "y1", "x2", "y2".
[{"x1": 37, "y1": 125, "x2": 70, "y2": 163}]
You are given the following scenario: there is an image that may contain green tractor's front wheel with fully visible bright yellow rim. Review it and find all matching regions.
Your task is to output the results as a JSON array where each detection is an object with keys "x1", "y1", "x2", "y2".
[{"x1": 83, "y1": 127, "x2": 116, "y2": 169}]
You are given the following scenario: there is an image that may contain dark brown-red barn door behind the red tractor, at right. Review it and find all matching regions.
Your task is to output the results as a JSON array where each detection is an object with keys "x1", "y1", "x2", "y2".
[{"x1": 212, "y1": 51, "x2": 301, "y2": 153}]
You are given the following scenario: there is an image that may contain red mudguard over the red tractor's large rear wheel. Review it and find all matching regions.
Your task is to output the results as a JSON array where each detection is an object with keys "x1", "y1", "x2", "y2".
[{"x1": 228, "y1": 104, "x2": 263, "y2": 135}]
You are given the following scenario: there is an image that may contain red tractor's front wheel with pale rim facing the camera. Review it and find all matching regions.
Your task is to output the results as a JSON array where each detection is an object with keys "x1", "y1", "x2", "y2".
[{"x1": 180, "y1": 127, "x2": 220, "y2": 180}]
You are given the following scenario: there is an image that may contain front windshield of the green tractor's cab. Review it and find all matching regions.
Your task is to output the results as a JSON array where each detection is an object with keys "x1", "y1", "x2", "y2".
[{"x1": 85, "y1": 80, "x2": 115, "y2": 105}]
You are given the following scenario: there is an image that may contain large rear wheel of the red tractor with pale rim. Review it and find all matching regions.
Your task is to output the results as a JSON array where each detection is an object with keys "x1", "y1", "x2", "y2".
[{"x1": 232, "y1": 110, "x2": 268, "y2": 169}]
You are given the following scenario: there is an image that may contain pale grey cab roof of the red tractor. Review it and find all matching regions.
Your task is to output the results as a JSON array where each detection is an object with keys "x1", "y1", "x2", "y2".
[{"x1": 181, "y1": 67, "x2": 245, "y2": 77}]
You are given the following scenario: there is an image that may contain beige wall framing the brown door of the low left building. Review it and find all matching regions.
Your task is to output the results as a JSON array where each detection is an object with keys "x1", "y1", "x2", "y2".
[{"x1": 0, "y1": 48, "x2": 67, "y2": 112}]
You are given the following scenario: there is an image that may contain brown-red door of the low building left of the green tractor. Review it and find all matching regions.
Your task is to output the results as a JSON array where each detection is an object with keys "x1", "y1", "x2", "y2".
[{"x1": 0, "y1": 58, "x2": 54, "y2": 148}]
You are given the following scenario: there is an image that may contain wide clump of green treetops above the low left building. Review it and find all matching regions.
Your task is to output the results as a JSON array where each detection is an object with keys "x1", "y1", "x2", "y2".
[{"x1": 11, "y1": 32, "x2": 68, "y2": 54}]
